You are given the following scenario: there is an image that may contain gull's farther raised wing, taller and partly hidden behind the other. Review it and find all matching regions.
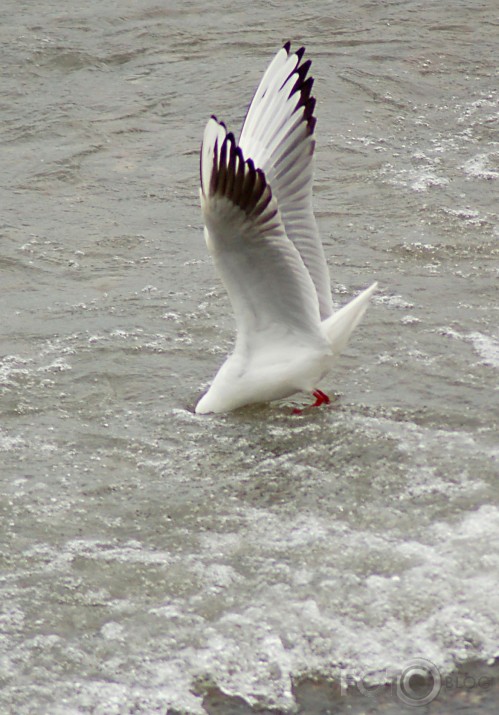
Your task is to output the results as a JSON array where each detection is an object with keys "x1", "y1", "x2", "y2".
[{"x1": 239, "y1": 42, "x2": 333, "y2": 320}]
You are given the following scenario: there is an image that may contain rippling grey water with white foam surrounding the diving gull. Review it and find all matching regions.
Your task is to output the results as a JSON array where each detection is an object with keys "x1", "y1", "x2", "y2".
[{"x1": 0, "y1": 0, "x2": 499, "y2": 715}]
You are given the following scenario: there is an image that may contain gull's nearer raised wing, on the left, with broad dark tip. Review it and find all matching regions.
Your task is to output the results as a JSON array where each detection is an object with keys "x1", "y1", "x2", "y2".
[{"x1": 200, "y1": 117, "x2": 322, "y2": 352}]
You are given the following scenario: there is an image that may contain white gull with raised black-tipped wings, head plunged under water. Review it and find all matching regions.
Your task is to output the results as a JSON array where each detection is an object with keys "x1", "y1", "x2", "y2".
[{"x1": 195, "y1": 42, "x2": 377, "y2": 414}]
